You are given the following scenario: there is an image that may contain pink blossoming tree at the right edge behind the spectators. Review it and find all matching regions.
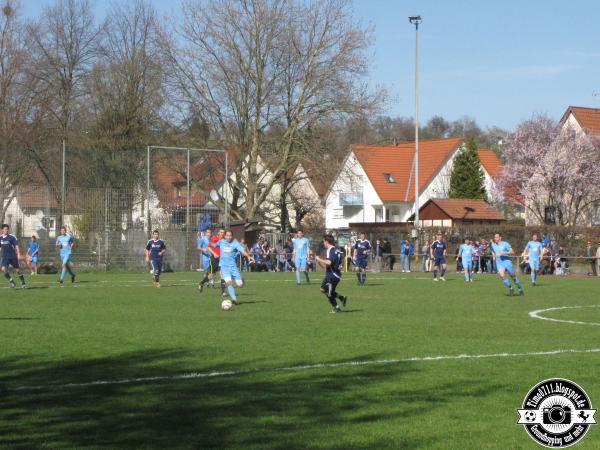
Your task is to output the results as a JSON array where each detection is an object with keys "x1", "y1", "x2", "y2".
[{"x1": 498, "y1": 115, "x2": 600, "y2": 226}]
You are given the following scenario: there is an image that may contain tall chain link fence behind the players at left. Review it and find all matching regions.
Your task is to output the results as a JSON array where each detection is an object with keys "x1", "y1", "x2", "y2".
[{"x1": 0, "y1": 146, "x2": 229, "y2": 272}]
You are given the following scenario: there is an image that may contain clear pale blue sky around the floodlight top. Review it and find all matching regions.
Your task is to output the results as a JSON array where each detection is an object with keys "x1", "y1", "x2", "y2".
[{"x1": 22, "y1": 0, "x2": 600, "y2": 129}]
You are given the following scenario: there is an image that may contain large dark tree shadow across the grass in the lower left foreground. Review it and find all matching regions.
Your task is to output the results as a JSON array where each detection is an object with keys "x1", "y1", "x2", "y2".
[{"x1": 0, "y1": 350, "x2": 499, "y2": 450}]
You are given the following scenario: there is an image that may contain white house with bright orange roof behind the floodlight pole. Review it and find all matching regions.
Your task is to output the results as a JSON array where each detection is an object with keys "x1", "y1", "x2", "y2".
[{"x1": 325, "y1": 137, "x2": 463, "y2": 229}]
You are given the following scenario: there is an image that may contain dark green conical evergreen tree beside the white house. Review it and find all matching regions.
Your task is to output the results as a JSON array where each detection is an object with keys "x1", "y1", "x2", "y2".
[{"x1": 449, "y1": 139, "x2": 486, "y2": 200}]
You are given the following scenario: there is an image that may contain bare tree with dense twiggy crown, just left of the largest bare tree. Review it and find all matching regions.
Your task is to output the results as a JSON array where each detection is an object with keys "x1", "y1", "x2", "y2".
[{"x1": 88, "y1": 0, "x2": 163, "y2": 187}]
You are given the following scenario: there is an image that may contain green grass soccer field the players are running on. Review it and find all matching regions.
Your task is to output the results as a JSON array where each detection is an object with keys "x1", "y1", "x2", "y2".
[{"x1": 0, "y1": 272, "x2": 600, "y2": 449}]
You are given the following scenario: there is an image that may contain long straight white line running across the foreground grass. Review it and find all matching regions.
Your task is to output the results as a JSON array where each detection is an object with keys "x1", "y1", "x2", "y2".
[{"x1": 0, "y1": 348, "x2": 600, "y2": 392}]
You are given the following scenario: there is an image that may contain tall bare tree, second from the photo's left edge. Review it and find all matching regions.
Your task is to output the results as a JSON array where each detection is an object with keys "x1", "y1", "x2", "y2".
[{"x1": 23, "y1": 0, "x2": 103, "y2": 225}]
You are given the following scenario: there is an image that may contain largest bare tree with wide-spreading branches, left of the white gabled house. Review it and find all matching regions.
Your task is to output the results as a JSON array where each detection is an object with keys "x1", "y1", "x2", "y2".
[{"x1": 168, "y1": 0, "x2": 375, "y2": 222}]
